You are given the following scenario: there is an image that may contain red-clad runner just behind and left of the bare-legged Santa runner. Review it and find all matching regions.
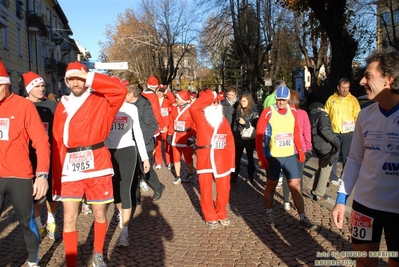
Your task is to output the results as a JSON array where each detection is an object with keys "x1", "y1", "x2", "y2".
[{"x1": 155, "y1": 84, "x2": 175, "y2": 171}]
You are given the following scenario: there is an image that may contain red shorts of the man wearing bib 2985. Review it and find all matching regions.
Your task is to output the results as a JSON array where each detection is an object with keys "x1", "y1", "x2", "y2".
[{"x1": 61, "y1": 175, "x2": 114, "y2": 204}]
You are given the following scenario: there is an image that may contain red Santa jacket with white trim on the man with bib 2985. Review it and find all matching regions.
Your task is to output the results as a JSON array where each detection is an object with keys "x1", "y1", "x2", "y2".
[{"x1": 52, "y1": 73, "x2": 127, "y2": 199}]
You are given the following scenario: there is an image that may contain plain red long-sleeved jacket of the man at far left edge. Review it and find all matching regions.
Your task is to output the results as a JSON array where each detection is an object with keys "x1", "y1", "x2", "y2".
[{"x1": 0, "y1": 94, "x2": 50, "y2": 179}]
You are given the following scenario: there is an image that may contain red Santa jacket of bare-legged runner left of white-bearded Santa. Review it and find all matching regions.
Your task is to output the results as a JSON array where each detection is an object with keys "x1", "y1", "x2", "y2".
[{"x1": 168, "y1": 104, "x2": 195, "y2": 147}]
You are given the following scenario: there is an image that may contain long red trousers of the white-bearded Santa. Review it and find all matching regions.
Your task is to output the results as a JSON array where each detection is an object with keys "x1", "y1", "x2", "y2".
[{"x1": 198, "y1": 173, "x2": 230, "y2": 222}]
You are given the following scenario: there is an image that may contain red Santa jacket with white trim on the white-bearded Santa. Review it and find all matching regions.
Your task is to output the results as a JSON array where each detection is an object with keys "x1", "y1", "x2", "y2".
[{"x1": 190, "y1": 90, "x2": 235, "y2": 178}]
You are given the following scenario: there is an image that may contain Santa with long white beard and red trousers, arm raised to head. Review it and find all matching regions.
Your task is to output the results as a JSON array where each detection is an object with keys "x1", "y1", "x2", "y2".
[{"x1": 190, "y1": 90, "x2": 235, "y2": 229}]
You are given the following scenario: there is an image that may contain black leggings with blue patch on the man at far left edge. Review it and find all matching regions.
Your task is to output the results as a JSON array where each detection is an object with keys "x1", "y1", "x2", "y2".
[{"x1": 0, "y1": 178, "x2": 40, "y2": 262}]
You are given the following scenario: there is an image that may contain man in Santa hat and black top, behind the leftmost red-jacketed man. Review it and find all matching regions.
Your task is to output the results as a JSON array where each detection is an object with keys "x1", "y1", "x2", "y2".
[{"x1": 22, "y1": 71, "x2": 59, "y2": 242}]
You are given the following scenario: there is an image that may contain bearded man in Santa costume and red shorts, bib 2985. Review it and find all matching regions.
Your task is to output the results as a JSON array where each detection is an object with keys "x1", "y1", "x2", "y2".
[{"x1": 52, "y1": 61, "x2": 127, "y2": 267}]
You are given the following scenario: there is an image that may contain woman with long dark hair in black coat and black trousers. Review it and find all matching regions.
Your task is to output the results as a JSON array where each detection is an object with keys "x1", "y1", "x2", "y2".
[{"x1": 231, "y1": 94, "x2": 259, "y2": 184}]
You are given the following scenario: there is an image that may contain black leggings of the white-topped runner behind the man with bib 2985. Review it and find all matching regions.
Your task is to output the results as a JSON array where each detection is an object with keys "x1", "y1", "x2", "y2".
[{"x1": 109, "y1": 146, "x2": 137, "y2": 209}]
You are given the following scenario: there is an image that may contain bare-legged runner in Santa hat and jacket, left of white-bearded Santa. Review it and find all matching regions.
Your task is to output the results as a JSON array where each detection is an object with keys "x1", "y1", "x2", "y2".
[{"x1": 167, "y1": 90, "x2": 195, "y2": 185}]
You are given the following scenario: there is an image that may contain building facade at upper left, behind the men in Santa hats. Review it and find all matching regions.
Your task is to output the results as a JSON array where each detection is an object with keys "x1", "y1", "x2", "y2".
[{"x1": 0, "y1": 0, "x2": 87, "y2": 97}]
